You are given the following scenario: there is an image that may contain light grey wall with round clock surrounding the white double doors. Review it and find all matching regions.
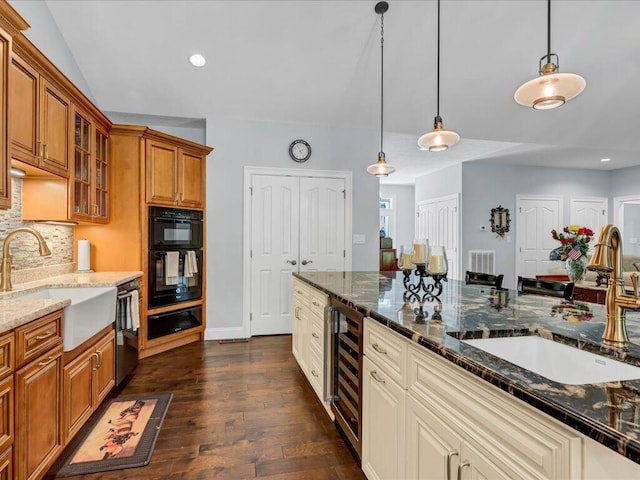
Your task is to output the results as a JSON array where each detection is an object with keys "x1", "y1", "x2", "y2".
[{"x1": 206, "y1": 115, "x2": 379, "y2": 338}]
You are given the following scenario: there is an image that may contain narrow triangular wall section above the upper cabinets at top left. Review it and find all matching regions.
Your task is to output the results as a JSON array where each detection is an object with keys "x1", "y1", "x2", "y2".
[{"x1": 9, "y1": 0, "x2": 95, "y2": 103}]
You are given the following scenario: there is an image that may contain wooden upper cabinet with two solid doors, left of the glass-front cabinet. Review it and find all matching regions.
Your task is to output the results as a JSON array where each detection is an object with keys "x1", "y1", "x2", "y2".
[{"x1": 9, "y1": 53, "x2": 71, "y2": 177}]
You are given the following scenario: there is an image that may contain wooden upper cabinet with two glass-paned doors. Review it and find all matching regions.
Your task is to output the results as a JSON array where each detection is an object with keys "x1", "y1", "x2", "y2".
[{"x1": 69, "y1": 107, "x2": 109, "y2": 223}]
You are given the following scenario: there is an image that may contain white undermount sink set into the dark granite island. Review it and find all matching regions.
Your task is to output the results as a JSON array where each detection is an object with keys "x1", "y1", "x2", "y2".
[{"x1": 461, "y1": 335, "x2": 640, "y2": 385}]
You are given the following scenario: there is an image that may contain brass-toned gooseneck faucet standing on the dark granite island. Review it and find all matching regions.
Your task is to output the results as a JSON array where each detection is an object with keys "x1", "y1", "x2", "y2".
[{"x1": 587, "y1": 225, "x2": 640, "y2": 349}]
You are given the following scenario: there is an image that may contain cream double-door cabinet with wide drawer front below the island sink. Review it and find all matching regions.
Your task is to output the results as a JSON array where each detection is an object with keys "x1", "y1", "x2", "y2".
[{"x1": 406, "y1": 345, "x2": 582, "y2": 480}]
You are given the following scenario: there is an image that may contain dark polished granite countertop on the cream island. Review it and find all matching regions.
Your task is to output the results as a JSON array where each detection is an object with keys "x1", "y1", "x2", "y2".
[{"x1": 294, "y1": 272, "x2": 640, "y2": 463}]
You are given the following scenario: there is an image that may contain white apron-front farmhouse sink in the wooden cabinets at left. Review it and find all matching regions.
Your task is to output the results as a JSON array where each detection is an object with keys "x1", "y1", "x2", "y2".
[{"x1": 16, "y1": 287, "x2": 117, "y2": 352}]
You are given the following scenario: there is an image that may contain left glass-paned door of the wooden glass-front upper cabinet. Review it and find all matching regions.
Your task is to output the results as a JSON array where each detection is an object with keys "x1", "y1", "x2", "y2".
[{"x1": 71, "y1": 112, "x2": 93, "y2": 219}]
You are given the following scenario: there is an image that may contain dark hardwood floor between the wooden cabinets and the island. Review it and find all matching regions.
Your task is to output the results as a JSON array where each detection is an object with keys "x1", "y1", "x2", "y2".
[{"x1": 55, "y1": 335, "x2": 365, "y2": 480}]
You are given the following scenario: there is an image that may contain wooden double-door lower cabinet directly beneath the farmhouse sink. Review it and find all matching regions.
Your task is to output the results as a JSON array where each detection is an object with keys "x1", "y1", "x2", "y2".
[{"x1": 62, "y1": 330, "x2": 115, "y2": 443}]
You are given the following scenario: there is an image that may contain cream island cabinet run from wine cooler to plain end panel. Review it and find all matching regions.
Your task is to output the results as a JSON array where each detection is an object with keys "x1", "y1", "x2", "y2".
[{"x1": 362, "y1": 318, "x2": 583, "y2": 480}]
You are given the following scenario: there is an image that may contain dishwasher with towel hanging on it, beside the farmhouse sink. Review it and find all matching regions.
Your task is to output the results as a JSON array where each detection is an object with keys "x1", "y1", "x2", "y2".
[{"x1": 115, "y1": 279, "x2": 141, "y2": 387}]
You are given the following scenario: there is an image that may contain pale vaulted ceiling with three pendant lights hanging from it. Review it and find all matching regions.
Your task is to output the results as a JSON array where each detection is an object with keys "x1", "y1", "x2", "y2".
[{"x1": 20, "y1": 0, "x2": 640, "y2": 184}]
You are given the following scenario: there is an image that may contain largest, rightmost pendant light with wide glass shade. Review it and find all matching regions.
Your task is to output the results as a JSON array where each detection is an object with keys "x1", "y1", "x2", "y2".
[{"x1": 514, "y1": 0, "x2": 586, "y2": 110}]
